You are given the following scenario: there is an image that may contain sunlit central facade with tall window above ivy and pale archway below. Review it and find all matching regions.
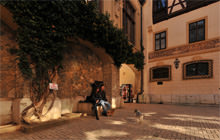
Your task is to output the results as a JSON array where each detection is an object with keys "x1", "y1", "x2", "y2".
[{"x1": 96, "y1": 0, "x2": 141, "y2": 95}]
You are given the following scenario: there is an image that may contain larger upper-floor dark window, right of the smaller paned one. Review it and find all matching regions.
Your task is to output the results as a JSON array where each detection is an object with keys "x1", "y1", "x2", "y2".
[{"x1": 189, "y1": 19, "x2": 205, "y2": 43}]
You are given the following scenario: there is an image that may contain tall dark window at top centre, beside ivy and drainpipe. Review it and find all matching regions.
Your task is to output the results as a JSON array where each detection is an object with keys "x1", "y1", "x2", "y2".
[{"x1": 123, "y1": 0, "x2": 135, "y2": 44}]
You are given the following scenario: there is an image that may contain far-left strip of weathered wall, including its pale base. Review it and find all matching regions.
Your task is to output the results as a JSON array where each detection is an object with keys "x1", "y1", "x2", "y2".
[{"x1": 0, "y1": 22, "x2": 16, "y2": 125}]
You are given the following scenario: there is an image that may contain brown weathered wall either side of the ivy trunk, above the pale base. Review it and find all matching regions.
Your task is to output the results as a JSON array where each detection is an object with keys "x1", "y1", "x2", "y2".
[{"x1": 0, "y1": 18, "x2": 119, "y2": 103}]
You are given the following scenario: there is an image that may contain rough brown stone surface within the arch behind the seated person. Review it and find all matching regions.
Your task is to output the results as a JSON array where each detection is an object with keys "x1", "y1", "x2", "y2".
[{"x1": 58, "y1": 45, "x2": 103, "y2": 98}]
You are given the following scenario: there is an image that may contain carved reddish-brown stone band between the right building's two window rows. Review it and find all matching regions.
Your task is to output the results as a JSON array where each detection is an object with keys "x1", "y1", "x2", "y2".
[{"x1": 148, "y1": 38, "x2": 220, "y2": 59}]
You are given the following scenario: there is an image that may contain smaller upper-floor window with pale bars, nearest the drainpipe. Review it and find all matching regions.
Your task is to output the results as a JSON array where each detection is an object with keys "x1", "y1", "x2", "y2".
[{"x1": 155, "y1": 31, "x2": 166, "y2": 51}]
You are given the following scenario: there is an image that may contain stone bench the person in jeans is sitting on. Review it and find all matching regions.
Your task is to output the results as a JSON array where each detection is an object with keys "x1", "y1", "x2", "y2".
[{"x1": 77, "y1": 102, "x2": 102, "y2": 116}]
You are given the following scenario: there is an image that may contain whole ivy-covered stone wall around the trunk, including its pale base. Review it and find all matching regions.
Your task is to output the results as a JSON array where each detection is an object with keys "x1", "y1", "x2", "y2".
[{"x1": 0, "y1": 5, "x2": 121, "y2": 125}]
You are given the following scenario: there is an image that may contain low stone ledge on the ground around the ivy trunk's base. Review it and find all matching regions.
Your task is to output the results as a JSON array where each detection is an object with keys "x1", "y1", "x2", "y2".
[{"x1": 21, "y1": 113, "x2": 82, "y2": 133}]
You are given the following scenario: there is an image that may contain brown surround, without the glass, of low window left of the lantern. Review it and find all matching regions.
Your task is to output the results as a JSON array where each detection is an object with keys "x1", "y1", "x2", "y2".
[{"x1": 149, "y1": 65, "x2": 172, "y2": 82}]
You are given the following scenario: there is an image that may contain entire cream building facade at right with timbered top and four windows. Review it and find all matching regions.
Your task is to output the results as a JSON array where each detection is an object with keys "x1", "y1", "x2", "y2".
[{"x1": 144, "y1": 0, "x2": 220, "y2": 104}]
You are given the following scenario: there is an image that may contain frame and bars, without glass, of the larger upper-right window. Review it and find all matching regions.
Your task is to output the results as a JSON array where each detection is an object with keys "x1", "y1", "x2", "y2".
[{"x1": 188, "y1": 18, "x2": 207, "y2": 44}]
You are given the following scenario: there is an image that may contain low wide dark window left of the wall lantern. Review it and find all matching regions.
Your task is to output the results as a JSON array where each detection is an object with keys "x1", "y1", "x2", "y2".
[{"x1": 150, "y1": 66, "x2": 171, "y2": 82}]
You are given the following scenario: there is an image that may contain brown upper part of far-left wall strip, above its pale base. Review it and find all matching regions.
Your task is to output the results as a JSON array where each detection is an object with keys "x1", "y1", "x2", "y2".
[{"x1": 0, "y1": 23, "x2": 16, "y2": 98}]
